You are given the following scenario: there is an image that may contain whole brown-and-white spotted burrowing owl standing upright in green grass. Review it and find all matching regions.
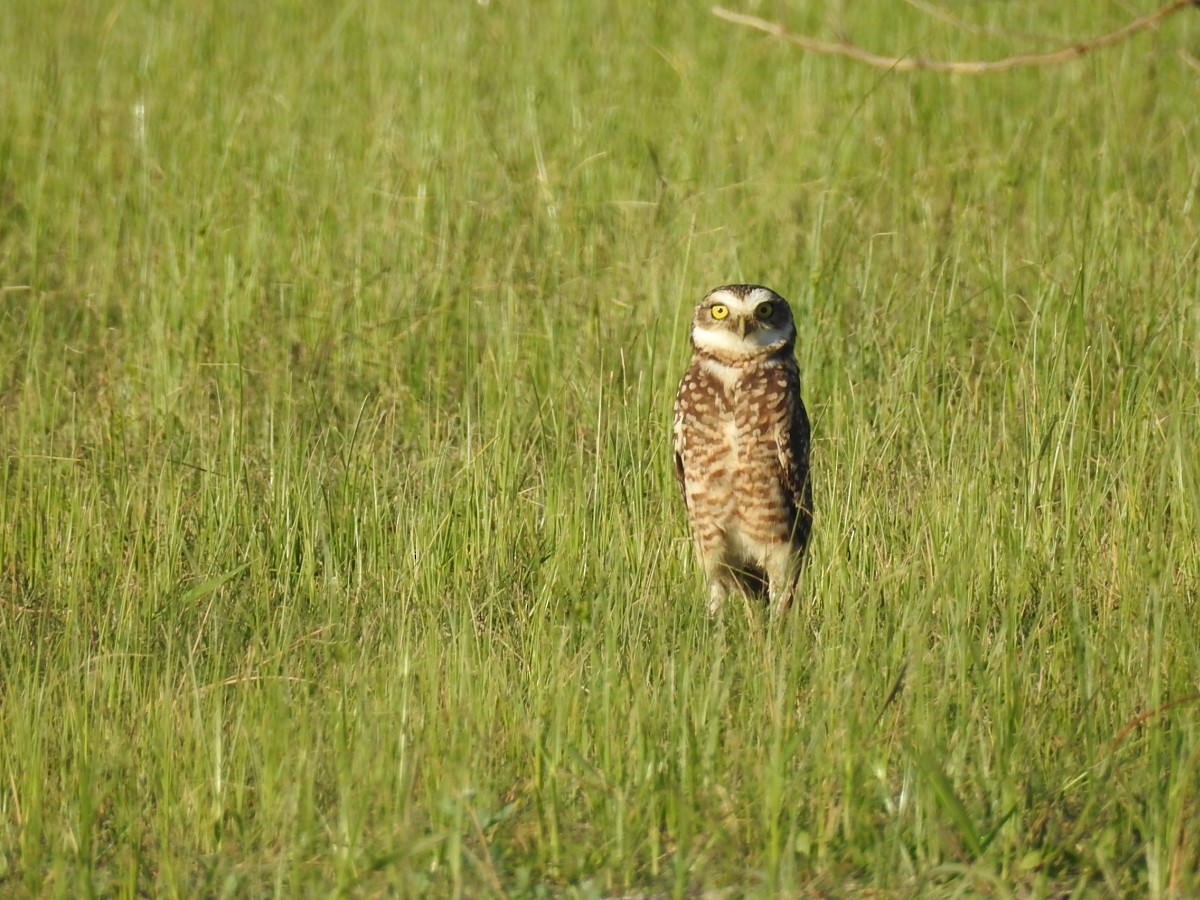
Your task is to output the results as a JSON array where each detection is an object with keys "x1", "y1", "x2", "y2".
[{"x1": 674, "y1": 284, "x2": 812, "y2": 613}]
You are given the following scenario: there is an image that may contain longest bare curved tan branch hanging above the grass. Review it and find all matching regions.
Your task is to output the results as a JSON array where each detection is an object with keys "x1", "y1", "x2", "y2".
[{"x1": 713, "y1": 0, "x2": 1200, "y2": 74}]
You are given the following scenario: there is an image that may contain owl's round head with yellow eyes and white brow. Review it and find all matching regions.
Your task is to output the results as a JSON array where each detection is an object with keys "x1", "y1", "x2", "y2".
[{"x1": 691, "y1": 284, "x2": 796, "y2": 359}]
